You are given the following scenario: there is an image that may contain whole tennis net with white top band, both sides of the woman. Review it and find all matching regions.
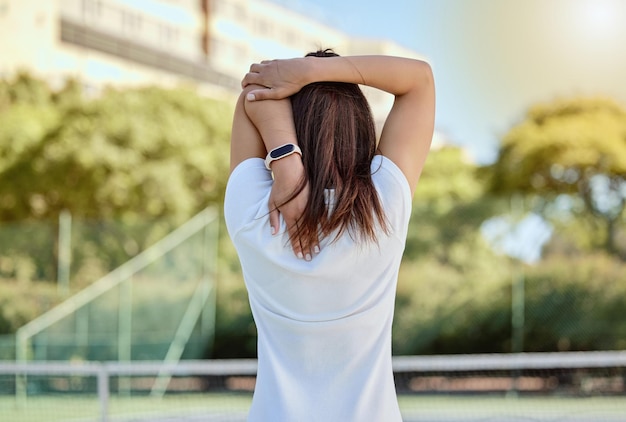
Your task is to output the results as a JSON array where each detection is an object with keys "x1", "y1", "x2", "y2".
[{"x1": 0, "y1": 351, "x2": 626, "y2": 422}]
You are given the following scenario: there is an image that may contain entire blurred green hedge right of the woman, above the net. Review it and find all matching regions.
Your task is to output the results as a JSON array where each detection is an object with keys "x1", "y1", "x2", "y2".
[{"x1": 393, "y1": 249, "x2": 626, "y2": 355}]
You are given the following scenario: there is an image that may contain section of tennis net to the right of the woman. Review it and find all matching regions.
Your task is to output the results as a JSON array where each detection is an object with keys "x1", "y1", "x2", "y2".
[{"x1": 394, "y1": 351, "x2": 626, "y2": 422}]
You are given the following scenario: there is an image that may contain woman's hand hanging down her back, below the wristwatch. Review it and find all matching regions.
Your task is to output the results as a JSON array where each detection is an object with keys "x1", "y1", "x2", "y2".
[{"x1": 269, "y1": 154, "x2": 319, "y2": 261}]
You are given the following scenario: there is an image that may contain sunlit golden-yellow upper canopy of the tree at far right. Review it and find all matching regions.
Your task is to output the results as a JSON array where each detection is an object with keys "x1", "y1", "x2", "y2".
[{"x1": 493, "y1": 98, "x2": 626, "y2": 194}]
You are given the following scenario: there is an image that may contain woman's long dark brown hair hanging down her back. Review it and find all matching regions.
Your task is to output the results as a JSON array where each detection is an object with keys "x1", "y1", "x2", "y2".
[{"x1": 291, "y1": 50, "x2": 387, "y2": 248}]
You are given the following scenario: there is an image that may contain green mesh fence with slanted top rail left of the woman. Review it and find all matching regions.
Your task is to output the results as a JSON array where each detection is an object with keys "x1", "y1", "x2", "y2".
[{"x1": 0, "y1": 210, "x2": 219, "y2": 361}]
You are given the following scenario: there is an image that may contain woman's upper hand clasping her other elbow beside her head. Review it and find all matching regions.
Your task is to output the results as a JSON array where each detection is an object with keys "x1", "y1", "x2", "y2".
[{"x1": 241, "y1": 58, "x2": 311, "y2": 101}]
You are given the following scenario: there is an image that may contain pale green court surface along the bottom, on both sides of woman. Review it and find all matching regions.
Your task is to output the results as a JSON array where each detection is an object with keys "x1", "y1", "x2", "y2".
[{"x1": 0, "y1": 395, "x2": 626, "y2": 422}]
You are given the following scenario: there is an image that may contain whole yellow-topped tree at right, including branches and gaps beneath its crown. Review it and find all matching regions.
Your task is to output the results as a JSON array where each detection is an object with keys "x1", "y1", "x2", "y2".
[{"x1": 490, "y1": 98, "x2": 626, "y2": 259}]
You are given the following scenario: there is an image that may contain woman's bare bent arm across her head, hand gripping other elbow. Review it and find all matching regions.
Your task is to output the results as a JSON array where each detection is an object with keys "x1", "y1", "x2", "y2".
[{"x1": 243, "y1": 56, "x2": 435, "y2": 192}]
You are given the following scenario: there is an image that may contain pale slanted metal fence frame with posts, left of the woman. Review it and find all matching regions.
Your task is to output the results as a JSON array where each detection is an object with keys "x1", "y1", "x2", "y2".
[{"x1": 15, "y1": 208, "x2": 219, "y2": 412}]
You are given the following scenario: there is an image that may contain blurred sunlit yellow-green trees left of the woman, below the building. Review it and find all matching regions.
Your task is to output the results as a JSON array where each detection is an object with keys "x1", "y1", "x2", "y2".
[{"x1": 0, "y1": 74, "x2": 231, "y2": 222}]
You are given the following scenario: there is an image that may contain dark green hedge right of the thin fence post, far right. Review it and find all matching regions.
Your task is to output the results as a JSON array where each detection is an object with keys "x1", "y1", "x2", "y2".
[{"x1": 525, "y1": 254, "x2": 626, "y2": 351}]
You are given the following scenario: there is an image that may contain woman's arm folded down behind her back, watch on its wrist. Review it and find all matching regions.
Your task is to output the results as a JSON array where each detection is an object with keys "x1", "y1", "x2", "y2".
[{"x1": 231, "y1": 85, "x2": 317, "y2": 259}]
